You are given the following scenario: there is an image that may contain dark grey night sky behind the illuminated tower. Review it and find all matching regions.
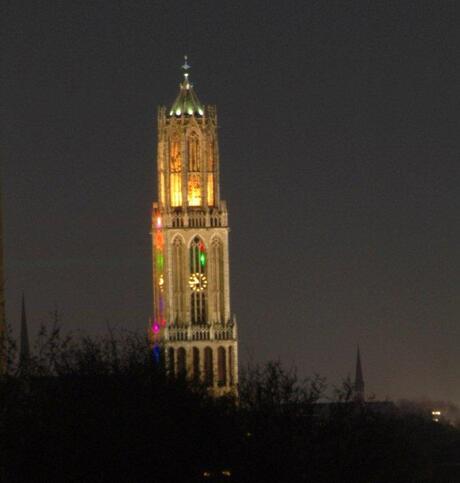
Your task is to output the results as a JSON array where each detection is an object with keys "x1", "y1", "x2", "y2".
[{"x1": 0, "y1": 0, "x2": 460, "y2": 403}]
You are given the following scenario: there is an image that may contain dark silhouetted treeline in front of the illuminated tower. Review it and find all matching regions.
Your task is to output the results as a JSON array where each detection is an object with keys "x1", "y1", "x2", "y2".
[{"x1": 0, "y1": 326, "x2": 460, "y2": 483}]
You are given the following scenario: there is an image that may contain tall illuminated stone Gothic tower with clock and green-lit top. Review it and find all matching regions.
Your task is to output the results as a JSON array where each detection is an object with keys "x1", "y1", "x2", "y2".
[{"x1": 150, "y1": 58, "x2": 238, "y2": 395}]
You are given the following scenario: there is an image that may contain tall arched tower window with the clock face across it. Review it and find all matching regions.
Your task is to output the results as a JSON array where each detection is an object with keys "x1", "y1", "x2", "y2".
[{"x1": 188, "y1": 237, "x2": 208, "y2": 324}]
